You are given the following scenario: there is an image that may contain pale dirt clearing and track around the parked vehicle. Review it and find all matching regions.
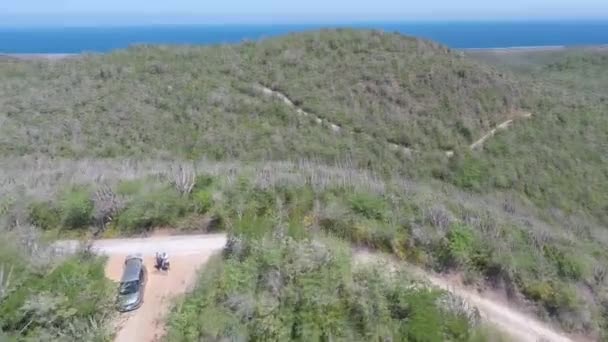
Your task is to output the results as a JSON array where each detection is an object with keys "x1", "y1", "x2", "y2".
[{"x1": 86, "y1": 235, "x2": 226, "y2": 342}]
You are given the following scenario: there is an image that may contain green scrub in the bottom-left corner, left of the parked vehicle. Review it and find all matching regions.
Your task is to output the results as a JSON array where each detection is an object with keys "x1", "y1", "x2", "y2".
[{"x1": 0, "y1": 227, "x2": 114, "y2": 342}]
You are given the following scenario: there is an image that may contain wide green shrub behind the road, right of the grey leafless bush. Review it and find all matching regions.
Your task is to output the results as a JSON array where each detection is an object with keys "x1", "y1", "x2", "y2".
[{"x1": 117, "y1": 186, "x2": 189, "y2": 232}]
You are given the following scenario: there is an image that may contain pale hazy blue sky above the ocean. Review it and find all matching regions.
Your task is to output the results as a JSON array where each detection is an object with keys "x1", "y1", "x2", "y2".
[{"x1": 0, "y1": 0, "x2": 608, "y2": 23}]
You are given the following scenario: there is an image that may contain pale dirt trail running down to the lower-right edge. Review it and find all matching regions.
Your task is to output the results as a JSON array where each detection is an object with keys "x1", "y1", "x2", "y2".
[{"x1": 354, "y1": 250, "x2": 575, "y2": 342}]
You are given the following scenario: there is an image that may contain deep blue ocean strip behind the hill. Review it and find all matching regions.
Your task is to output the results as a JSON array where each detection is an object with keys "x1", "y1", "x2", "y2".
[{"x1": 0, "y1": 20, "x2": 608, "y2": 53}]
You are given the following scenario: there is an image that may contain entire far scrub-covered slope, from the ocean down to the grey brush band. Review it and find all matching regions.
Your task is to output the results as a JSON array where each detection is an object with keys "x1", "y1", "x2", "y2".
[{"x1": 0, "y1": 30, "x2": 608, "y2": 225}]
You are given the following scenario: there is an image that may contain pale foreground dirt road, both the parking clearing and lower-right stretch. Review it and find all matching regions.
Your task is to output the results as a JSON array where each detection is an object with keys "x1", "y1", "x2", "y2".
[{"x1": 57, "y1": 235, "x2": 574, "y2": 342}]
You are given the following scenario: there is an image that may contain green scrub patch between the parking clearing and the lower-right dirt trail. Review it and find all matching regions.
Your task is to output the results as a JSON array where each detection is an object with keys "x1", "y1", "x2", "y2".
[{"x1": 166, "y1": 232, "x2": 489, "y2": 342}]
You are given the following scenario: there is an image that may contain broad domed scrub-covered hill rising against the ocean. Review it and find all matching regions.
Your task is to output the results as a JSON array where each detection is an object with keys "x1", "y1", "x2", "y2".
[{"x1": 0, "y1": 30, "x2": 521, "y2": 160}]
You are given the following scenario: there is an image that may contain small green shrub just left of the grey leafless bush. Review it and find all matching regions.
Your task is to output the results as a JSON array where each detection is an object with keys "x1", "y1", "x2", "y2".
[{"x1": 59, "y1": 187, "x2": 93, "y2": 229}]
